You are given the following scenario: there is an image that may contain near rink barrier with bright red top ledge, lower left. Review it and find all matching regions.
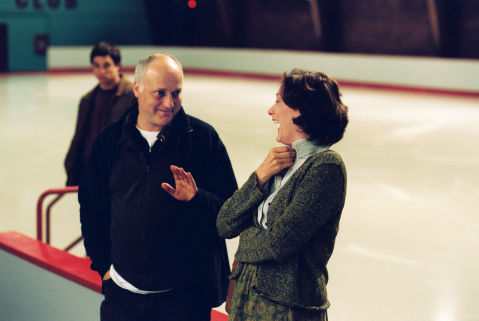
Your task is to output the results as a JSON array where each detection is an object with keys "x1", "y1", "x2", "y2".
[{"x1": 0, "y1": 232, "x2": 227, "y2": 321}]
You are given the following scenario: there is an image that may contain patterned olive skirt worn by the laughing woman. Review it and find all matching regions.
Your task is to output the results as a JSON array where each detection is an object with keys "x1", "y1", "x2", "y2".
[{"x1": 228, "y1": 264, "x2": 328, "y2": 321}]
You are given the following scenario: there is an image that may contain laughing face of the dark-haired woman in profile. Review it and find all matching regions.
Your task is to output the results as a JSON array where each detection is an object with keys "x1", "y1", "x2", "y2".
[{"x1": 268, "y1": 88, "x2": 308, "y2": 145}]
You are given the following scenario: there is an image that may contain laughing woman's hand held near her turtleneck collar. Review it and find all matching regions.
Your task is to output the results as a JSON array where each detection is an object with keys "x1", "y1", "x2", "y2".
[{"x1": 256, "y1": 146, "x2": 296, "y2": 188}]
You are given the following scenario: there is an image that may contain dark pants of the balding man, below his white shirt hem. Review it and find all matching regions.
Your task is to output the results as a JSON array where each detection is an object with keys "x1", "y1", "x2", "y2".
[{"x1": 100, "y1": 279, "x2": 211, "y2": 321}]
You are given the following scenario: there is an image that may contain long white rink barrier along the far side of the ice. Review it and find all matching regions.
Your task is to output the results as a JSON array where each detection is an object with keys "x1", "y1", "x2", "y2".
[{"x1": 47, "y1": 46, "x2": 479, "y2": 96}]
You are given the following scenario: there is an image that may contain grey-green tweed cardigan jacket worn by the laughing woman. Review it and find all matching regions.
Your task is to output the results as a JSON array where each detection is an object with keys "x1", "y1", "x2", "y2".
[{"x1": 216, "y1": 150, "x2": 346, "y2": 310}]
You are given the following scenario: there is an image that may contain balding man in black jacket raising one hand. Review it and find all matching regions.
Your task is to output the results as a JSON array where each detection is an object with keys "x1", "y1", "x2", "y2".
[{"x1": 79, "y1": 53, "x2": 237, "y2": 321}]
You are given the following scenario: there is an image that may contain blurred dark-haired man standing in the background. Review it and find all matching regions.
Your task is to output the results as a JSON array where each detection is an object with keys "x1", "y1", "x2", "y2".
[{"x1": 65, "y1": 42, "x2": 135, "y2": 186}]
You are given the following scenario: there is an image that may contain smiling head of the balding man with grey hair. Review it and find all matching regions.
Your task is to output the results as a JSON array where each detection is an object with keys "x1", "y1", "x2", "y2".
[{"x1": 133, "y1": 56, "x2": 183, "y2": 131}]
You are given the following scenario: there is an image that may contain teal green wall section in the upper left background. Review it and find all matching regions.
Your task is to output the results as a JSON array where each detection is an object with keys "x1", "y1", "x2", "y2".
[{"x1": 0, "y1": 0, "x2": 151, "y2": 71}]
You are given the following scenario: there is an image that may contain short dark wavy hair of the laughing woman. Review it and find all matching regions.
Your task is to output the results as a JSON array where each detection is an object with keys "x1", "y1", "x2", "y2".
[{"x1": 280, "y1": 68, "x2": 348, "y2": 146}]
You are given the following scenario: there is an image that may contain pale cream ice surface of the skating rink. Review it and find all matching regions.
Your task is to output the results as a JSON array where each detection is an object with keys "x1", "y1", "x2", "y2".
[{"x1": 0, "y1": 74, "x2": 479, "y2": 321}]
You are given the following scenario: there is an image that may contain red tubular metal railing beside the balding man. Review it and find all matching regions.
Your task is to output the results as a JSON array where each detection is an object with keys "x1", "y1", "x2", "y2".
[{"x1": 37, "y1": 186, "x2": 83, "y2": 251}]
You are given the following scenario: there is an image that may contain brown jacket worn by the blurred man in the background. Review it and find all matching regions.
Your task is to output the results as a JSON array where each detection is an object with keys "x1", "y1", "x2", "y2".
[{"x1": 65, "y1": 76, "x2": 136, "y2": 186}]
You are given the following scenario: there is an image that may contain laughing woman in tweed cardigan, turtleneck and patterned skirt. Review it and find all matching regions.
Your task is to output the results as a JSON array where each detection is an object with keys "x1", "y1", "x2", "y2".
[{"x1": 217, "y1": 69, "x2": 348, "y2": 321}]
